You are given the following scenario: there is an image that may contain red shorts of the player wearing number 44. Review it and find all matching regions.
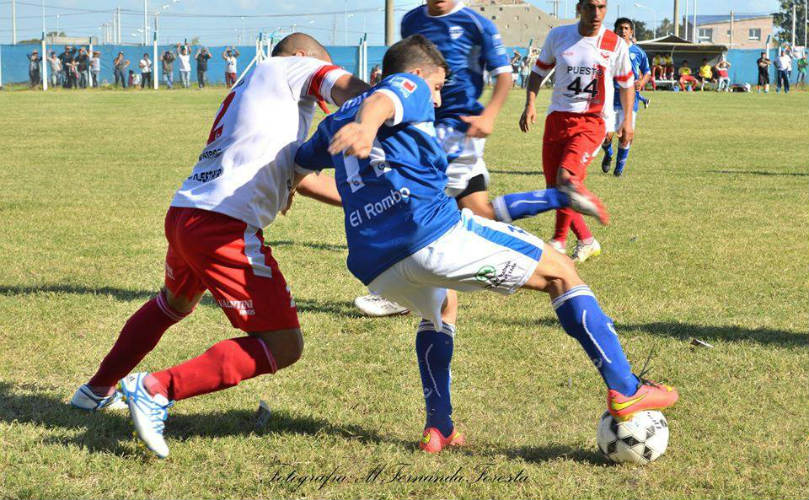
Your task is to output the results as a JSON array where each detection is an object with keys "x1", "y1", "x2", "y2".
[{"x1": 542, "y1": 111, "x2": 607, "y2": 186}]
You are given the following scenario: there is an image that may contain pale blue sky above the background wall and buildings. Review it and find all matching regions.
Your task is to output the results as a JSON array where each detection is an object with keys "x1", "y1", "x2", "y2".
[{"x1": 0, "y1": 0, "x2": 779, "y2": 46}]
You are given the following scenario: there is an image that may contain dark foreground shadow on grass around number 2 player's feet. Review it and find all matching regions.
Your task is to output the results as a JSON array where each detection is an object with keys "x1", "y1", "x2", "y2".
[{"x1": 0, "y1": 381, "x2": 408, "y2": 455}]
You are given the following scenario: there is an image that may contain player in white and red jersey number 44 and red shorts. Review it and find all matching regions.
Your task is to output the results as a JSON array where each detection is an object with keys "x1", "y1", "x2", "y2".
[{"x1": 520, "y1": 0, "x2": 635, "y2": 262}]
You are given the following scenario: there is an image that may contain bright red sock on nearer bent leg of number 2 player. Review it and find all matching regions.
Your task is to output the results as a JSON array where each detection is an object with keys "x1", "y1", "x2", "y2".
[{"x1": 149, "y1": 337, "x2": 278, "y2": 401}]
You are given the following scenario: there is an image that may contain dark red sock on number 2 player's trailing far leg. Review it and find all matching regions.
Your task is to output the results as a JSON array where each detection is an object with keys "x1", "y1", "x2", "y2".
[{"x1": 88, "y1": 291, "x2": 188, "y2": 387}]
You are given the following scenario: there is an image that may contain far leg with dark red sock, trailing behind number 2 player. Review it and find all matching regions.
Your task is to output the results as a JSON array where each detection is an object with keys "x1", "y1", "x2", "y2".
[{"x1": 71, "y1": 210, "x2": 205, "y2": 411}]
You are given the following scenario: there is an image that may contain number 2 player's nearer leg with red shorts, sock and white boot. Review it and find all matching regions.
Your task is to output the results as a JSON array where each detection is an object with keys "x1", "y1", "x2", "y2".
[{"x1": 121, "y1": 209, "x2": 303, "y2": 457}]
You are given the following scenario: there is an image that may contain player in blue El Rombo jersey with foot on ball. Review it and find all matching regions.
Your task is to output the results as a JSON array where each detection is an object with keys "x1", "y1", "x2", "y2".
[{"x1": 295, "y1": 35, "x2": 677, "y2": 452}]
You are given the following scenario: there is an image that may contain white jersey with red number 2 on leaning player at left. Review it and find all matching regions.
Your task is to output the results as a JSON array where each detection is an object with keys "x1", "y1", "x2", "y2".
[{"x1": 171, "y1": 57, "x2": 348, "y2": 228}]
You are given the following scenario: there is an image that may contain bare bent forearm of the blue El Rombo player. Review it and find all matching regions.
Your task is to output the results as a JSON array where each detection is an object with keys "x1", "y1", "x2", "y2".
[{"x1": 329, "y1": 92, "x2": 396, "y2": 158}]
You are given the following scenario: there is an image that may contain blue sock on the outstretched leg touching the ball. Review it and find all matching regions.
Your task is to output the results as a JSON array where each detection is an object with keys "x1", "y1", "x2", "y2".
[{"x1": 548, "y1": 285, "x2": 640, "y2": 396}]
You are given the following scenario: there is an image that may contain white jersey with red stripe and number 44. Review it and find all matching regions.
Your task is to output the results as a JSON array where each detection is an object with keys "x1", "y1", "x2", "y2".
[{"x1": 533, "y1": 24, "x2": 635, "y2": 118}]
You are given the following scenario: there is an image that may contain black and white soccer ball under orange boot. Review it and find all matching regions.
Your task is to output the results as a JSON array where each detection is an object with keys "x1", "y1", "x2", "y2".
[{"x1": 596, "y1": 411, "x2": 669, "y2": 465}]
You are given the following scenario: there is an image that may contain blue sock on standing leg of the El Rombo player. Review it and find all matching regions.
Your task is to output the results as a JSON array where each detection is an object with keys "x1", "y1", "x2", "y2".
[{"x1": 416, "y1": 319, "x2": 455, "y2": 437}]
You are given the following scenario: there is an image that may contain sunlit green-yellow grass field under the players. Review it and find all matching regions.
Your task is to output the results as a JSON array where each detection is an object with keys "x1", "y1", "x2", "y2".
[{"x1": 0, "y1": 88, "x2": 809, "y2": 499}]
